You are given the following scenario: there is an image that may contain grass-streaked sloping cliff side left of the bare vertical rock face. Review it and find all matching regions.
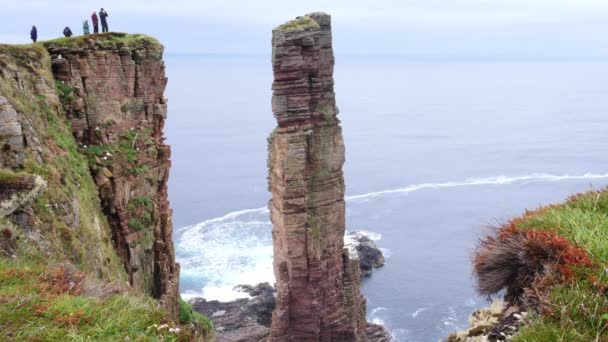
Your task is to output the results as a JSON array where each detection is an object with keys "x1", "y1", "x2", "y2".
[{"x1": 0, "y1": 45, "x2": 124, "y2": 281}]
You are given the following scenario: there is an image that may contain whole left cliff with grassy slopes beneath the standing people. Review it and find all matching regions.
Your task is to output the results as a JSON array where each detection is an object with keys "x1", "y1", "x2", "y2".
[{"x1": 0, "y1": 34, "x2": 212, "y2": 340}]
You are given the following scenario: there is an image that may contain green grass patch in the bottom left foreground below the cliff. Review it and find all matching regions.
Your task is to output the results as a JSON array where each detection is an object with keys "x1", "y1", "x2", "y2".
[{"x1": 0, "y1": 259, "x2": 202, "y2": 341}]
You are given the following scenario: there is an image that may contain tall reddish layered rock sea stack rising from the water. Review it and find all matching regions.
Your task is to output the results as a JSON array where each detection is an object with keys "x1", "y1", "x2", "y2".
[{"x1": 268, "y1": 13, "x2": 366, "y2": 341}]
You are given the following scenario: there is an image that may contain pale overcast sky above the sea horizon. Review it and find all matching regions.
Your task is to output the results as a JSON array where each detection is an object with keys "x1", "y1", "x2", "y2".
[{"x1": 0, "y1": 0, "x2": 608, "y2": 58}]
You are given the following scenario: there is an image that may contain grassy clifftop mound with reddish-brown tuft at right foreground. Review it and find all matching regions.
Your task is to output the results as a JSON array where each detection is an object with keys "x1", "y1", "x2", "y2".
[{"x1": 475, "y1": 190, "x2": 608, "y2": 342}]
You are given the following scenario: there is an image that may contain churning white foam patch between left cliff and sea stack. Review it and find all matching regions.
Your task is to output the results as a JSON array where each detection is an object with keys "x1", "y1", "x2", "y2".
[{"x1": 175, "y1": 208, "x2": 274, "y2": 301}]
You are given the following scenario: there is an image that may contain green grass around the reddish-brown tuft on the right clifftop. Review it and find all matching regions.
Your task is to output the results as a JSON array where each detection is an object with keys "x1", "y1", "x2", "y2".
[{"x1": 482, "y1": 189, "x2": 608, "y2": 342}]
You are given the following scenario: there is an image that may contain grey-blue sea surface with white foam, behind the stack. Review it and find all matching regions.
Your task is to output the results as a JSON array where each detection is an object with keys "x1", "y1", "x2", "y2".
[{"x1": 166, "y1": 55, "x2": 608, "y2": 341}]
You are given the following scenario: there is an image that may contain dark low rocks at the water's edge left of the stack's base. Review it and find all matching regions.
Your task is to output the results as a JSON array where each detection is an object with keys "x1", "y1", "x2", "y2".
[{"x1": 190, "y1": 283, "x2": 276, "y2": 342}]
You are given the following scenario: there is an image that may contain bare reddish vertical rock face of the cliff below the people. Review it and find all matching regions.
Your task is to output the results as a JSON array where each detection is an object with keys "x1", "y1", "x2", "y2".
[{"x1": 45, "y1": 34, "x2": 179, "y2": 317}]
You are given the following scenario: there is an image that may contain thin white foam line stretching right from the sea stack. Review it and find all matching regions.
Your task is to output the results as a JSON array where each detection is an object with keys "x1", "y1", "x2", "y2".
[{"x1": 346, "y1": 173, "x2": 608, "y2": 201}]
